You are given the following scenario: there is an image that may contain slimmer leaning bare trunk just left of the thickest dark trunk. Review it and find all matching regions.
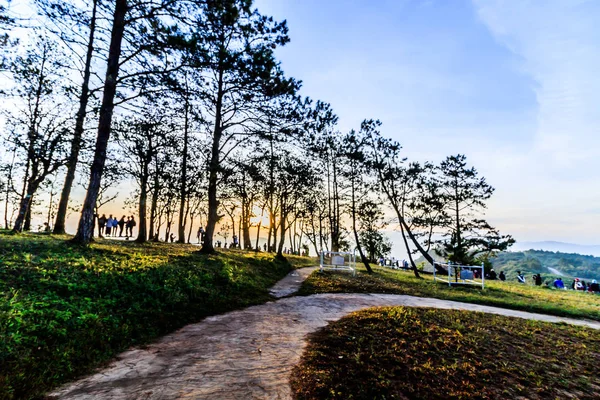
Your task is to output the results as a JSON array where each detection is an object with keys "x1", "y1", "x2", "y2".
[{"x1": 54, "y1": 0, "x2": 98, "y2": 235}]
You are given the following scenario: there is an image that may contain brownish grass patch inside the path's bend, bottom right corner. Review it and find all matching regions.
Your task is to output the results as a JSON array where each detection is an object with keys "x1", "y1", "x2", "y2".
[{"x1": 291, "y1": 307, "x2": 600, "y2": 399}]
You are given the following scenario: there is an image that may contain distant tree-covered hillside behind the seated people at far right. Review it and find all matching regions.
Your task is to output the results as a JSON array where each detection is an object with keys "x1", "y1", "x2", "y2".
[{"x1": 492, "y1": 250, "x2": 600, "y2": 279}]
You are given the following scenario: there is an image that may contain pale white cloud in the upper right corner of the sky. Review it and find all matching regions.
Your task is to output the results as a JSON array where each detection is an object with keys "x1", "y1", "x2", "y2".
[{"x1": 474, "y1": 0, "x2": 600, "y2": 172}]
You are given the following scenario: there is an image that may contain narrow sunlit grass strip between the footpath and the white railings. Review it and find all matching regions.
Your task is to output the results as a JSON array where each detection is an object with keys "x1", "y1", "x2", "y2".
[{"x1": 298, "y1": 267, "x2": 600, "y2": 321}]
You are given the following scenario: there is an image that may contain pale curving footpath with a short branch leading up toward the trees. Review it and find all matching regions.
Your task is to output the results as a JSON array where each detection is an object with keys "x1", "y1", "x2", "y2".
[{"x1": 50, "y1": 268, "x2": 600, "y2": 399}]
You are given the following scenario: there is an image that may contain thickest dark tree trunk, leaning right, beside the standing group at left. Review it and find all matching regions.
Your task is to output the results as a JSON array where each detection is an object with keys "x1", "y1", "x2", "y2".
[{"x1": 73, "y1": 0, "x2": 128, "y2": 244}]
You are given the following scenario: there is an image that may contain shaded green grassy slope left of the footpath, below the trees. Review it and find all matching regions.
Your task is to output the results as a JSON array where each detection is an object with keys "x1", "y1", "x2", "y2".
[{"x1": 0, "y1": 231, "x2": 311, "y2": 399}]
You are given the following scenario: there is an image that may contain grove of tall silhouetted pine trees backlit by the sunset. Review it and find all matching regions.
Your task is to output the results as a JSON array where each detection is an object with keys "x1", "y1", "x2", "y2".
[{"x1": 0, "y1": 0, "x2": 512, "y2": 273}]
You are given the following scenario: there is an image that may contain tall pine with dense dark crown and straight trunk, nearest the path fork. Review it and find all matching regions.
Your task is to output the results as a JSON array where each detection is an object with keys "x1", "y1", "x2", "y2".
[{"x1": 191, "y1": 0, "x2": 298, "y2": 253}]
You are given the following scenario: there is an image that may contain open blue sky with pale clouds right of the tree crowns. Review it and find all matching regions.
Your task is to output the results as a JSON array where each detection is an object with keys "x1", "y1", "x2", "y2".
[{"x1": 255, "y1": 0, "x2": 600, "y2": 250}]
